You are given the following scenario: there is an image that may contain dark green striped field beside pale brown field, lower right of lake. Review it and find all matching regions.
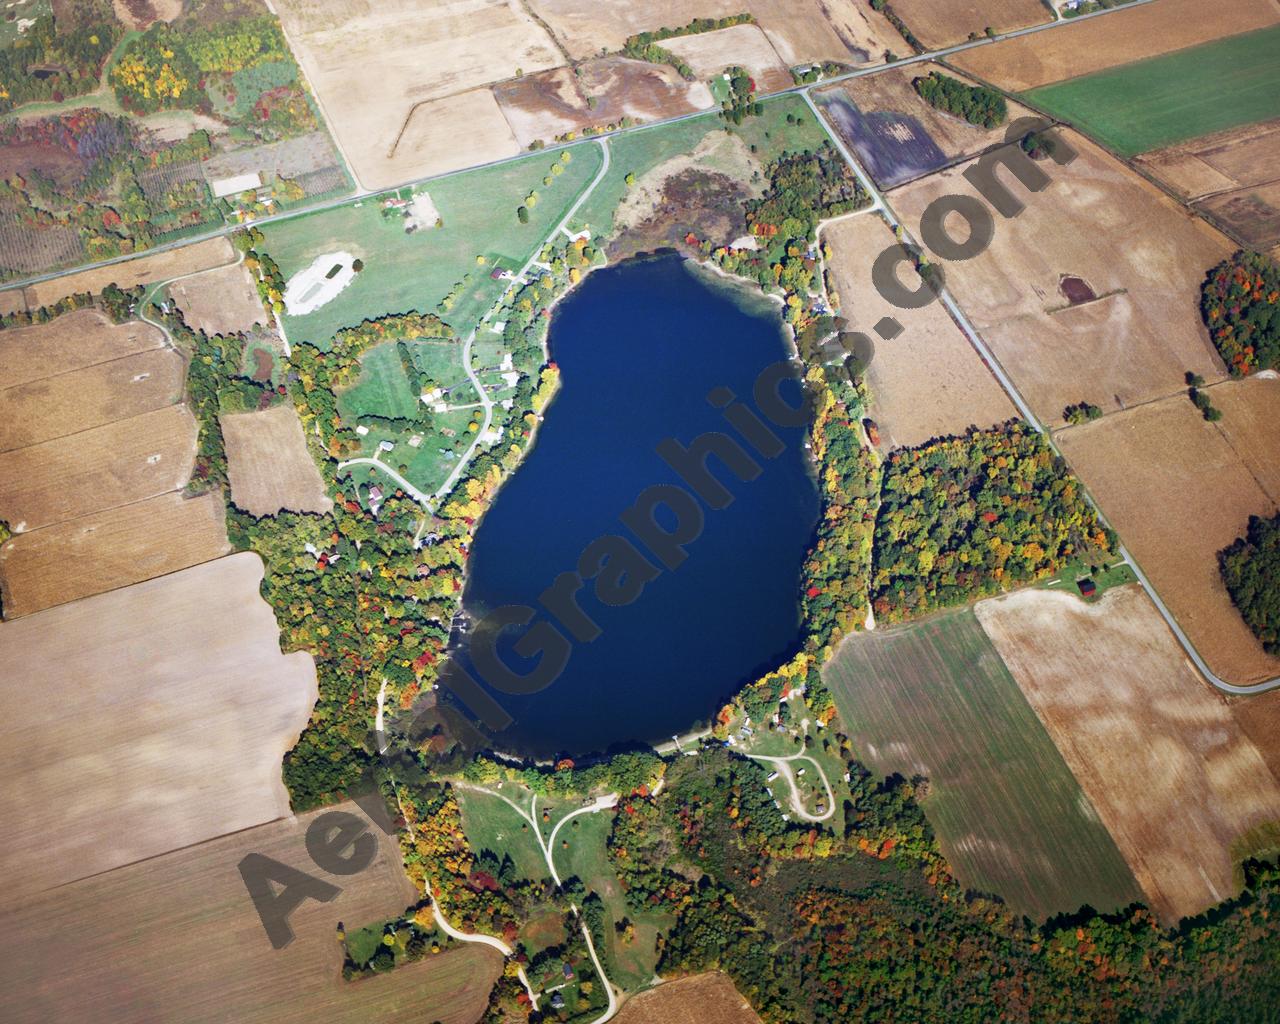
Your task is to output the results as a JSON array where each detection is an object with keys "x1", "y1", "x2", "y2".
[{"x1": 823, "y1": 611, "x2": 1138, "y2": 919}]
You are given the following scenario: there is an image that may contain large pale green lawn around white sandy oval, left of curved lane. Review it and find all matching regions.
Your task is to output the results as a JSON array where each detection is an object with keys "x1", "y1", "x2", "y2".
[{"x1": 262, "y1": 145, "x2": 603, "y2": 348}]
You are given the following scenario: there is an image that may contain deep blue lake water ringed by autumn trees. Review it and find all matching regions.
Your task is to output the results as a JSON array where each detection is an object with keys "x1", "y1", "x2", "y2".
[{"x1": 458, "y1": 256, "x2": 818, "y2": 756}]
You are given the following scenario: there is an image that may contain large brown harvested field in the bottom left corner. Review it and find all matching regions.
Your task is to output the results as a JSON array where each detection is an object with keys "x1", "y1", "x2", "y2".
[{"x1": 0, "y1": 804, "x2": 502, "y2": 1024}]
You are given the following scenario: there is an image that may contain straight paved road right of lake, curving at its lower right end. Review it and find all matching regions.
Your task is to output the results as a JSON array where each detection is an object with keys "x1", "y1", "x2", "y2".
[{"x1": 804, "y1": 90, "x2": 1280, "y2": 696}]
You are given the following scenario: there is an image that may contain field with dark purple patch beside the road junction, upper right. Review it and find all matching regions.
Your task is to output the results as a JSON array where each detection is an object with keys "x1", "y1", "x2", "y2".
[{"x1": 818, "y1": 63, "x2": 1030, "y2": 188}]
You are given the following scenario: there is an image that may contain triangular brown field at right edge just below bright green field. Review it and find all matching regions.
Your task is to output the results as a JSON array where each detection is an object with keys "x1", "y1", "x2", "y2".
[{"x1": 1137, "y1": 119, "x2": 1280, "y2": 250}]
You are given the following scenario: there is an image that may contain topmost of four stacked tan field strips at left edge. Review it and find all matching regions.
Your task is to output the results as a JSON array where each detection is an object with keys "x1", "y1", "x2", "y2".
[{"x1": 0, "y1": 310, "x2": 164, "y2": 392}]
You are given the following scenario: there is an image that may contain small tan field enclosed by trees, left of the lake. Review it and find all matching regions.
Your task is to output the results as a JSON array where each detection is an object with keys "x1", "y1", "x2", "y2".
[{"x1": 221, "y1": 403, "x2": 333, "y2": 516}]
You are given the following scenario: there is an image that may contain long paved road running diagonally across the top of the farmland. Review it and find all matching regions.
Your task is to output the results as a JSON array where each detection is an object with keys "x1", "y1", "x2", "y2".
[{"x1": 0, "y1": 0, "x2": 1155, "y2": 295}]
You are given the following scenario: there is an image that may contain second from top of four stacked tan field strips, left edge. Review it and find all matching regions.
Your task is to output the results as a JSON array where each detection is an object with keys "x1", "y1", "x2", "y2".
[{"x1": 0, "y1": 348, "x2": 187, "y2": 452}]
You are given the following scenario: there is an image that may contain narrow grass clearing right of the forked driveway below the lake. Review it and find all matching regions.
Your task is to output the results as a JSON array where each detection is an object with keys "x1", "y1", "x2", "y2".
[{"x1": 553, "y1": 812, "x2": 675, "y2": 991}]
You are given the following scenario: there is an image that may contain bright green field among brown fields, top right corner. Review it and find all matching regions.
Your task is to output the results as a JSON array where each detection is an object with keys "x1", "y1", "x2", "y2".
[{"x1": 1025, "y1": 25, "x2": 1280, "y2": 156}]
